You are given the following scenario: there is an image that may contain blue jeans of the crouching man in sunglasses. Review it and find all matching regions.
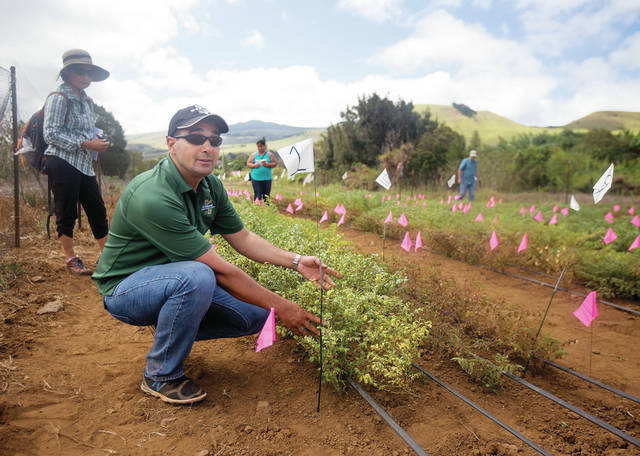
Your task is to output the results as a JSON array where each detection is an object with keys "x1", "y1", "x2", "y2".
[{"x1": 103, "y1": 261, "x2": 269, "y2": 381}]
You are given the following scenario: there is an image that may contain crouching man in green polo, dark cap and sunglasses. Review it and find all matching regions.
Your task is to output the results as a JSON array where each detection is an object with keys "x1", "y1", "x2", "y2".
[{"x1": 93, "y1": 105, "x2": 340, "y2": 404}]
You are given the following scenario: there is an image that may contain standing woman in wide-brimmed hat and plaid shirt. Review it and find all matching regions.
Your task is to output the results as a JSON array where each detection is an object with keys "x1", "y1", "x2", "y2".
[{"x1": 44, "y1": 49, "x2": 109, "y2": 274}]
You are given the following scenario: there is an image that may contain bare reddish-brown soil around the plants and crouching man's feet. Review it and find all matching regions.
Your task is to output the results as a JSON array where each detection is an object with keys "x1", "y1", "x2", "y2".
[{"x1": 0, "y1": 209, "x2": 640, "y2": 456}]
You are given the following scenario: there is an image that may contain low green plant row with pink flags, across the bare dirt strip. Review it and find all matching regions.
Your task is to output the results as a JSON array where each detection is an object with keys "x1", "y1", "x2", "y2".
[{"x1": 262, "y1": 184, "x2": 640, "y2": 300}]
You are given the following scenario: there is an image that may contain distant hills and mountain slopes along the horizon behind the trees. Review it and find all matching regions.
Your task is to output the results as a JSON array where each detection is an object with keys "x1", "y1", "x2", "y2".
[{"x1": 127, "y1": 108, "x2": 640, "y2": 156}]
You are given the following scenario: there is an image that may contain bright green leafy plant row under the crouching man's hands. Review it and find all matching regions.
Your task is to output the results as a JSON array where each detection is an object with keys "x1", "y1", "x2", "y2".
[{"x1": 216, "y1": 200, "x2": 430, "y2": 391}]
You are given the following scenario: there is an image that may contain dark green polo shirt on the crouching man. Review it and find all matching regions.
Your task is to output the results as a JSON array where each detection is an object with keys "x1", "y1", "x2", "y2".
[{"x1": 92, "y1": 157, "x2": 244, "y2": 296}]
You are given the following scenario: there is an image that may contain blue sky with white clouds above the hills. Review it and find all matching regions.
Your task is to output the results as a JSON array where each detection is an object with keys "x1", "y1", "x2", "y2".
[{"x1": 0, "y1": 0, "x2": 640, "y2": 133}]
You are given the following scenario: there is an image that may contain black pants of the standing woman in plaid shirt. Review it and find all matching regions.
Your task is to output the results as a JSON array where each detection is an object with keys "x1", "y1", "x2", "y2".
[{"x1": 45, "y1": 155, "x2": 109, "y2": 239}]
